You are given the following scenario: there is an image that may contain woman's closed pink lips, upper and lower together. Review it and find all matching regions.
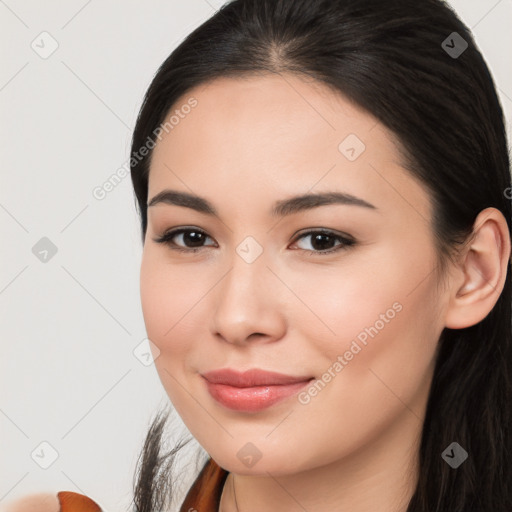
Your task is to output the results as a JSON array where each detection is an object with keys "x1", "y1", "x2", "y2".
[{"x1": 201, "y1": 368, "x2": 314, "y2": 412}]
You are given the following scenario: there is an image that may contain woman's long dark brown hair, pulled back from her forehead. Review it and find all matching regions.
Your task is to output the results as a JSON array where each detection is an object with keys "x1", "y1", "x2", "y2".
[{"x1": 131, "y1": 0, "x2": 512, "y2": 512}]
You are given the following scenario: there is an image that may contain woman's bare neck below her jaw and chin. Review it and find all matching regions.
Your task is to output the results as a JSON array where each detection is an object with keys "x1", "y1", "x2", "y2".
[{"x1": 219, "y1": 409, "x2": 422, "y2": 512}]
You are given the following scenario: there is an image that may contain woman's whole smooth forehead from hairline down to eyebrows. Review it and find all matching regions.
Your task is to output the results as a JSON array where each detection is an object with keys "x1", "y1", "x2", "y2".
[{"x1": 148, "y1": 74, "x2": 430, "y2": 224}]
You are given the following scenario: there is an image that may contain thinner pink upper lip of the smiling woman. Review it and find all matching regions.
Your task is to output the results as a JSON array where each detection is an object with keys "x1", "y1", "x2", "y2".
[{"x1": 201, "y1": 368, "x2": 313, "y2": 388}]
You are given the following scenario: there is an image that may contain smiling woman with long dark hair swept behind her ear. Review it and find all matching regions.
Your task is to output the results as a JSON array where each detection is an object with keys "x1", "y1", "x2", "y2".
[{"x1": 6, "y1": 0, "x2": 512, "y2": 512}]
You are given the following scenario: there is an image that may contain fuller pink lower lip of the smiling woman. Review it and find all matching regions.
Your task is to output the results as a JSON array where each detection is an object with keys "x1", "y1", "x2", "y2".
[{"x1": 205, "y1": 379, "x2": 312, "y2": 412}]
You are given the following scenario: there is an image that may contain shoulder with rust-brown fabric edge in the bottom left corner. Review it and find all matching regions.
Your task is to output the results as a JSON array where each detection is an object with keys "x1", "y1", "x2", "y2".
[{"x1": 0, "y1": 491, "x2": 101, "y2": 512}]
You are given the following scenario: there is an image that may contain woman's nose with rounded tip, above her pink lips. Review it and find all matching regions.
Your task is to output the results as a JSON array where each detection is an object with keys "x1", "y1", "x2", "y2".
[{"x1": 211, "y1": 249, "x2": 289, "y2": 345}]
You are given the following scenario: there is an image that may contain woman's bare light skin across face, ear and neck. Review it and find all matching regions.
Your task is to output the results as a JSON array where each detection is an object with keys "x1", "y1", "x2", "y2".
[{"x1": 140, "y1": 74, "x2": 510, "y2": 512}]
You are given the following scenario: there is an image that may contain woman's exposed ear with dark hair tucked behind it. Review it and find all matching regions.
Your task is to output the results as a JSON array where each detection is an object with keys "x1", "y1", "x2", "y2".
[{"x1": 445, "y1": 208, "x2": 511, "y2": 329}]
